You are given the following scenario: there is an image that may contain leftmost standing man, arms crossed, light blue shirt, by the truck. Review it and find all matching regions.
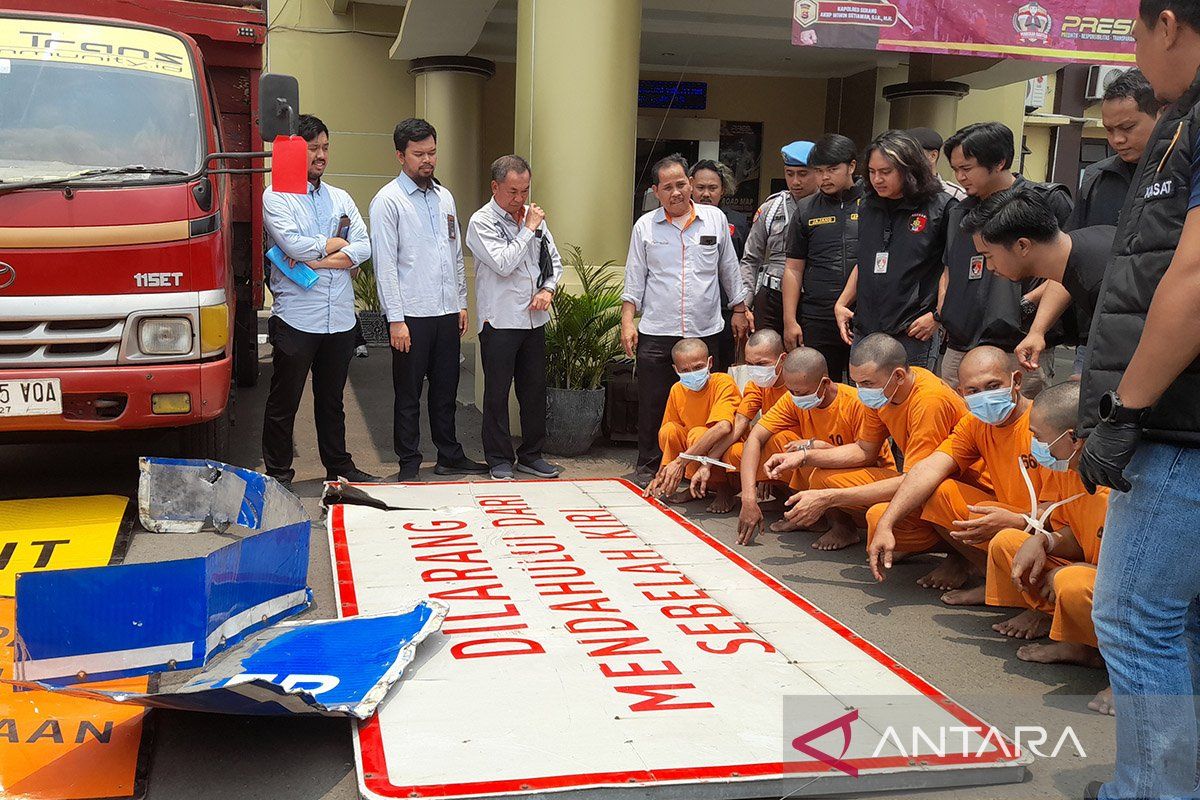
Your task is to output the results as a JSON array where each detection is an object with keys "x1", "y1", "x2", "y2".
[{"x1": 263, "y1": 114, "x2": 379, "y2": 485}]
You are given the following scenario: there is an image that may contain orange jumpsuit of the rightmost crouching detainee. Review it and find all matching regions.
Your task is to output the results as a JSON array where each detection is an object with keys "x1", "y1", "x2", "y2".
[{"x1": 986, "y1": 470, "x2": 1109, "y2": 648}]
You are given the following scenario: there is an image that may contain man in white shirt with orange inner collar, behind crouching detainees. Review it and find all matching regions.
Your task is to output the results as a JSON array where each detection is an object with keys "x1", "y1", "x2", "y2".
[{"x1": 620, "y1": 154, "x2": 754, "y2": 479}]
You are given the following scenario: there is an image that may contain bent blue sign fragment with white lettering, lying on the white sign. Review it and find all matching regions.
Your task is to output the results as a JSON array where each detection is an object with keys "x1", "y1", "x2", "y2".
[{"x1": 17, "y1": 601, "x2": 446, "y2": 720}]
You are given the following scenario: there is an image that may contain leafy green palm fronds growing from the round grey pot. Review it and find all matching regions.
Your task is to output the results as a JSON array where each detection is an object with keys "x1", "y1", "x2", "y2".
[{"x1": 546, "y1": 245, "x2": 622, "y2": 389}]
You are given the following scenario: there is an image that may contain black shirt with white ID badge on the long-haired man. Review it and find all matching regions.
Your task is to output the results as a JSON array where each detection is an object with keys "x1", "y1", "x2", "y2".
[{"x1": 854, "y1": 191, "x2": 958, "y2": 337}]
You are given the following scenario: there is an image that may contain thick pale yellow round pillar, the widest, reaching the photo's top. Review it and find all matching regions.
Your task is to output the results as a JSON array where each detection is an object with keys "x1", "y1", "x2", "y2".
[{"x1": 515, "y1": 0, "x2": 642, "y2": 264}]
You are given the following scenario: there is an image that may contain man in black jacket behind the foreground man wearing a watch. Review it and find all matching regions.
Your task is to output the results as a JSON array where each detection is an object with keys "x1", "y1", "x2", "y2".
[{"x1": 1063, "y1": 68, "x2": 1162, "y2": 230}]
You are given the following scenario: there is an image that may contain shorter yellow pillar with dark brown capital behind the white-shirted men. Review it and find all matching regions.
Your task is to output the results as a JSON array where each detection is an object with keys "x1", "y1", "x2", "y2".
[{"x1": 408, "y1": 55, "x2": 496, "y2": 214}]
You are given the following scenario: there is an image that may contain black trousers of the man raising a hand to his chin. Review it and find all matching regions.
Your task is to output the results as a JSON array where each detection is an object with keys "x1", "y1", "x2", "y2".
[{"x1": 479, "y1": 323, "x2": 546, "y2": 467}]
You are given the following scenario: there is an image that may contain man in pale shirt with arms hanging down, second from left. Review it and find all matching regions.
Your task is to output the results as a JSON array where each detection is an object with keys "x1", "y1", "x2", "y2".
[{"x1": 371, "y1": 119, "x2": 487, "y2": 481}]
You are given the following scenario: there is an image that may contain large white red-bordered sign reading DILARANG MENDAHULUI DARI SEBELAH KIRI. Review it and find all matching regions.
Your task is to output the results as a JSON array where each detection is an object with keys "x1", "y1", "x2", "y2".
[{"x1": 329, "y1": 480, "x2": 1030, "y2": 800}]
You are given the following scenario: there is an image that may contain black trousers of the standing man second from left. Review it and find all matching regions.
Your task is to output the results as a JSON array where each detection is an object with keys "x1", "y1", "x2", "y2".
[{"x1": 391, "y1": 314, "x2": 466, "y2": 471}]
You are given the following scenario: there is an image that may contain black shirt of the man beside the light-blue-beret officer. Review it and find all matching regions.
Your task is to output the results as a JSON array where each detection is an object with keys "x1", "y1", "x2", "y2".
[{"x1": 787, "y1": 184, "x2": 863, "y2": 319}]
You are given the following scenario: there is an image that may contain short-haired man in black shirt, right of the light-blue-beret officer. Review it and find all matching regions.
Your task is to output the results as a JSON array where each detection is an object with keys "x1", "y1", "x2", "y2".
[{"x1": 782, "y1": 133, "x2": 863, "y2": 381}]
